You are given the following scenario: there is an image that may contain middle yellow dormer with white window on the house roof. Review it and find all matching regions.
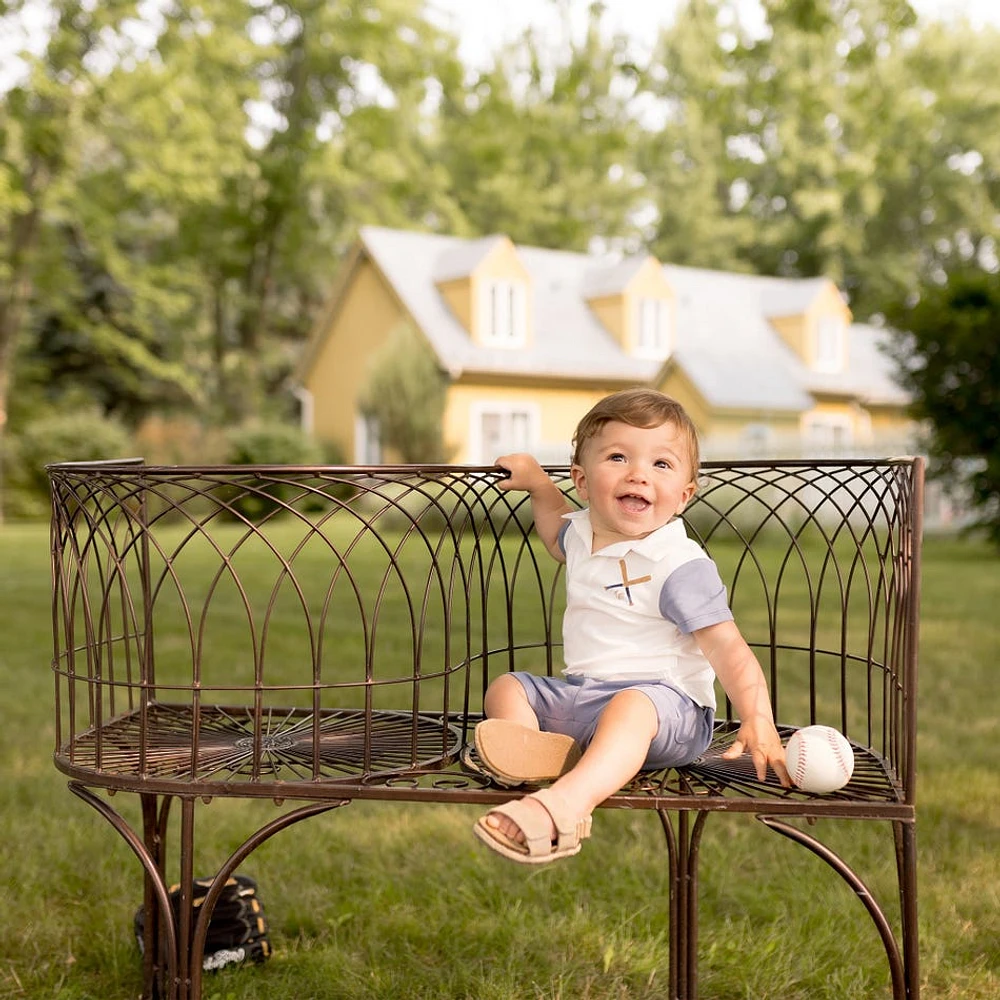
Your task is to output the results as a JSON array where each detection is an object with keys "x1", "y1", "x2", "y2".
[{"x1": 583, "y1": 256, "x2": 676, "y2": 361}]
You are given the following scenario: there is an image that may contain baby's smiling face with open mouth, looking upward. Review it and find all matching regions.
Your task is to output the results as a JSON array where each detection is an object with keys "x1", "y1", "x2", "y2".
[{"x1": 572, "y1": 420, "x2": 695, "y2": 549}]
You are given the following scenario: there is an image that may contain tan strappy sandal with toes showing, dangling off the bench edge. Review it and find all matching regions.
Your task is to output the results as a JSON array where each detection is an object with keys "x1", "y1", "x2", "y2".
[{"x1": 473, "y1": 788, "x2": 591, "y2": 865}]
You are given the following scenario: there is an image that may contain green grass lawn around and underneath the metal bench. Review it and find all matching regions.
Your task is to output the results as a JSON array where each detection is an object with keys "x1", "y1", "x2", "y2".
[{"x1": 0, "y1": 526, "x2": 1000, "y2": 1000}]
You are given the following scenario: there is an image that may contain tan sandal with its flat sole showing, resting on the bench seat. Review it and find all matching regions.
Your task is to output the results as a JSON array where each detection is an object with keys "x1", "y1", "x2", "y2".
[{"x1": 475, "y1": 719, "x2": 581, "y2": 785}]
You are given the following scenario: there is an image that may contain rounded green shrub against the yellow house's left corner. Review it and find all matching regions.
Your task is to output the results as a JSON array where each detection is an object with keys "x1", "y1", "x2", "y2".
[{"x1": 358, "y1": 325, "x2": 448, "y2": 464}]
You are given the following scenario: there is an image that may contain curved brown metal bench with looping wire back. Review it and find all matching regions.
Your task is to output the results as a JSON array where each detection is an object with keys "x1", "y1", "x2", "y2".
[{"x1": 49, "y1": 458, "x2": 923, "y2": 1000}]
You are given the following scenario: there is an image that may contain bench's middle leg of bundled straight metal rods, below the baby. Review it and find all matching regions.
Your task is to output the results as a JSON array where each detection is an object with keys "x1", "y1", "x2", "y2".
[{"x1": 657, "y1": 809, "x2": 708, "y2": 1000}]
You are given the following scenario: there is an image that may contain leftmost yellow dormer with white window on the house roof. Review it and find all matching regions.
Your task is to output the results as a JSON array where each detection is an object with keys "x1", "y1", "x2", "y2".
[{"x1": 434, "y1": 236, "x2": 532, "y2": 349}]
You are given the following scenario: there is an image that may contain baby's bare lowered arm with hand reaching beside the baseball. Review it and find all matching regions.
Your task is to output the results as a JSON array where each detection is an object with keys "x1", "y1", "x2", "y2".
[{"x1": 693, "y1": 621, "x2": 792, "y2": 788}]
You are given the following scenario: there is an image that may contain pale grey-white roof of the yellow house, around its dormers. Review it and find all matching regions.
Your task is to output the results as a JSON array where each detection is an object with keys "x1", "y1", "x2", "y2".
[{"x1": 361, "y1": 226, "x2": 907, "y2": 411}]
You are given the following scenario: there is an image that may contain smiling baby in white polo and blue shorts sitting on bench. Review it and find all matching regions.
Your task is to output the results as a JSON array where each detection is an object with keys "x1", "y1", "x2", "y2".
[{"x1": 475, "y1": 388, "x2": 791, "y2": 864}]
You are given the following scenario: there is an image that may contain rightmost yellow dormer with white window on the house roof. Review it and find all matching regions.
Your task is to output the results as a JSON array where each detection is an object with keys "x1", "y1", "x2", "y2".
[{"x1": 764, "y1": 278, "x2": 853, "y2": 375}]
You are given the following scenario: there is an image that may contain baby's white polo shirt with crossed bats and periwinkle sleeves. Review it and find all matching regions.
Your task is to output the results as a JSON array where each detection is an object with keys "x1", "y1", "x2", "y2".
[{"x1": 559, "y1": 510, "x2": 733, "y2": 709}]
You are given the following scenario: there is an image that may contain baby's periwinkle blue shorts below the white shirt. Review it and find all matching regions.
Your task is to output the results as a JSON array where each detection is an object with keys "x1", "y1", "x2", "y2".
[{"x1": 513, "y1": 671, "x2": 715, "y2": 771}]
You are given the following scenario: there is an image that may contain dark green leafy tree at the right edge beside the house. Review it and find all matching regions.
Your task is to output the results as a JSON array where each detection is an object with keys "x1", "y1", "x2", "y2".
[{"x1": 890, "y1": 268, "x2": 1000, "y2": 547}]
